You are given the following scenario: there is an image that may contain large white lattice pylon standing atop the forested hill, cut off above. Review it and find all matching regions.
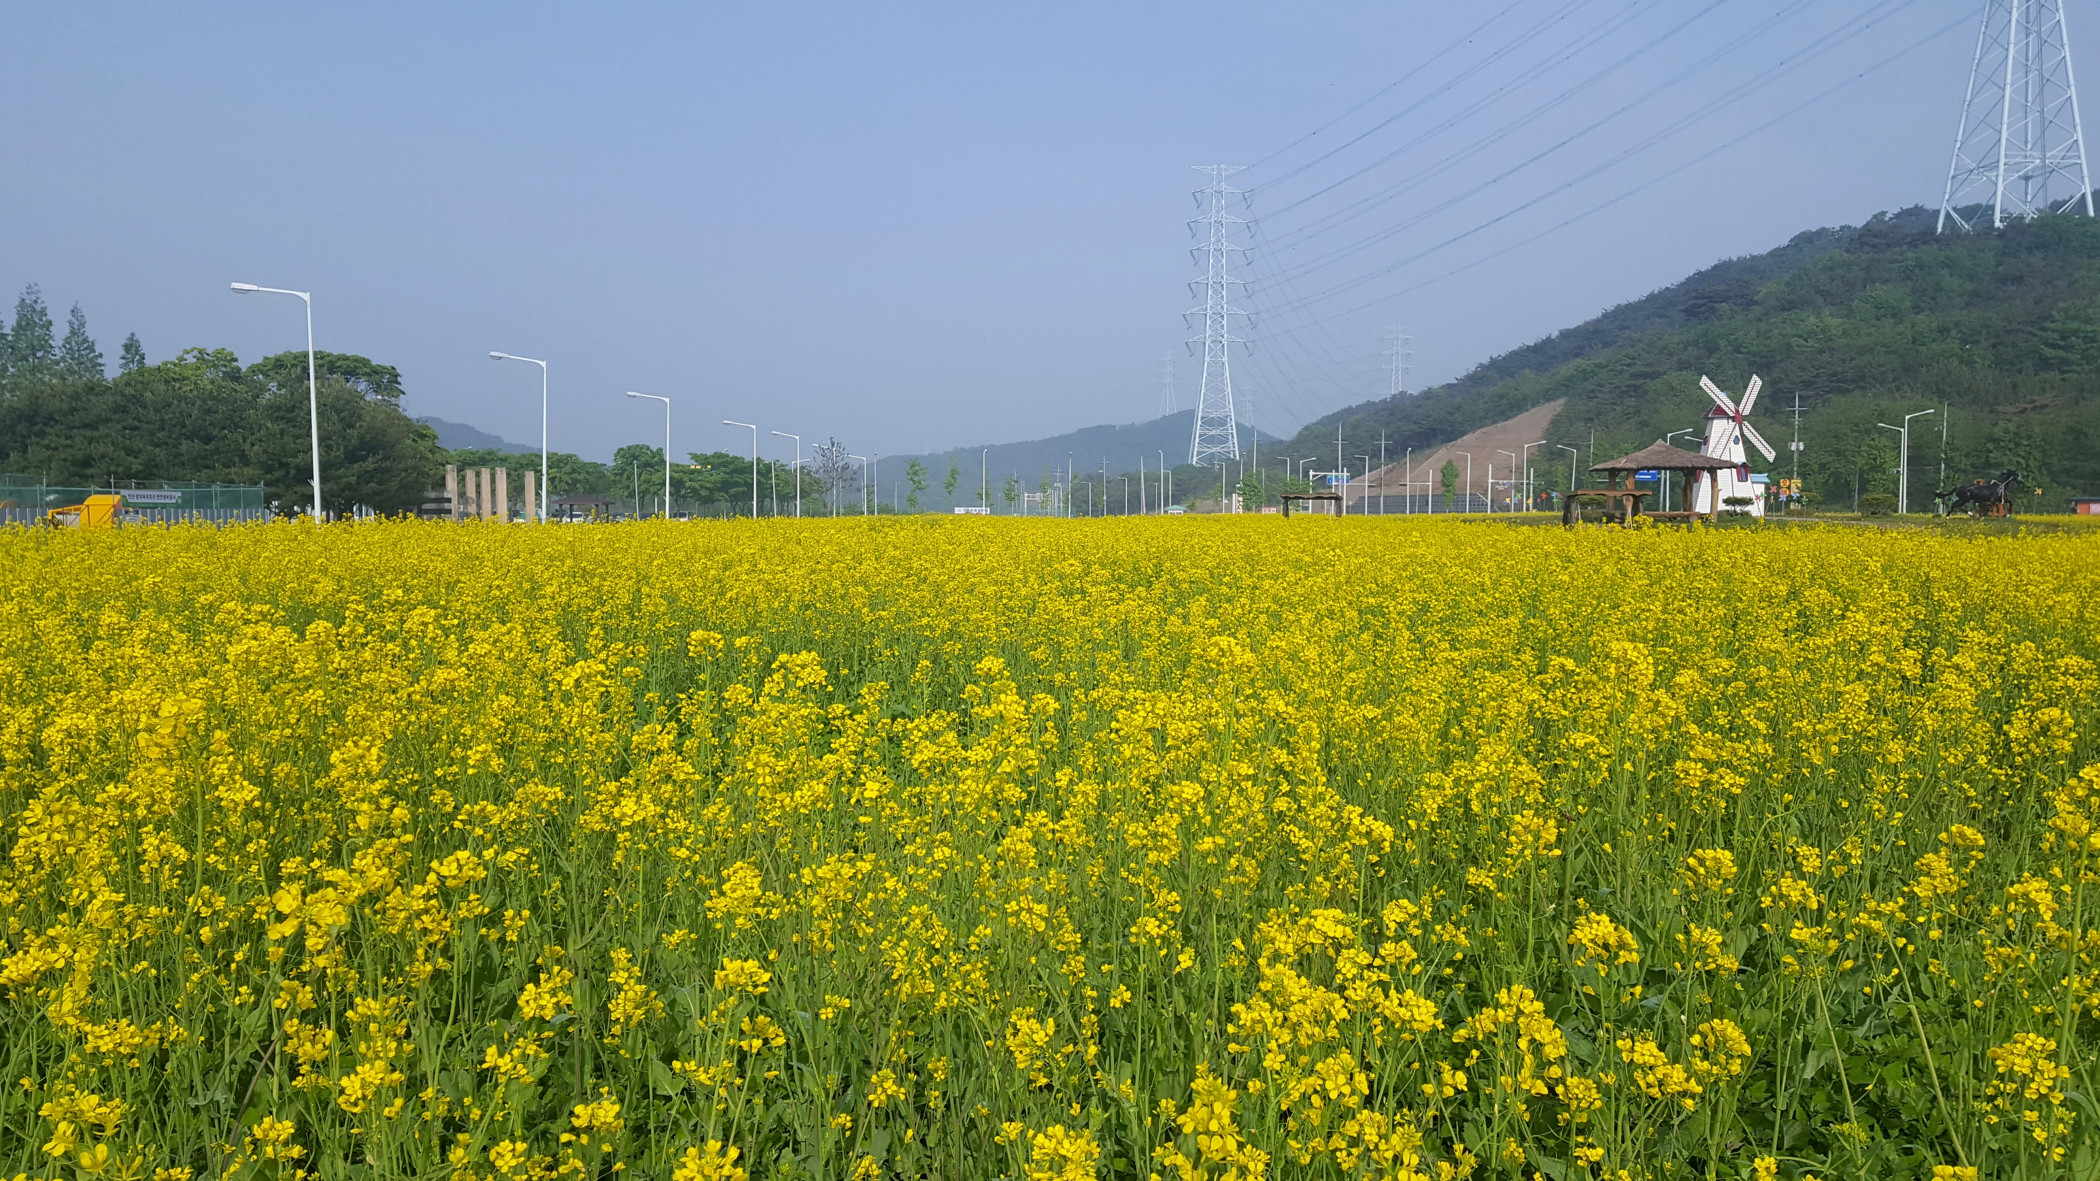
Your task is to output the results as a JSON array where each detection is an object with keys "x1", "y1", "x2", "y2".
[{"x1": 1938, "y1": 0, "x2": 2094, "y2": 231}]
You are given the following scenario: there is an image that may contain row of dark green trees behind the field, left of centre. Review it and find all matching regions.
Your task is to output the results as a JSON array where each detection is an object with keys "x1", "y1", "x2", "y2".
[{"x1": 0, "y1": 284, "x2": 936, "y2": 515}]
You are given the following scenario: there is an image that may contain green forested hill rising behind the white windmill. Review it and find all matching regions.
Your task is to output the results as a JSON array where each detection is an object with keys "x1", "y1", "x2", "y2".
[{"x1": 1292, "y1": 208, "x2": 2100, "y2": 509}]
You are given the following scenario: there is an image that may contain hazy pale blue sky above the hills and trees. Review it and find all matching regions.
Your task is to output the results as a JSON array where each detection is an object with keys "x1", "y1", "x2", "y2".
[{"x1": 0, "y1": 0, "x2": 2015, "y2": 458}]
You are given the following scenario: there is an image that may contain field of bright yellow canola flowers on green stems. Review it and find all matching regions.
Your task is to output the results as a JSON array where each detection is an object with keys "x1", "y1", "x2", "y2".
[{"x1": 0, "y1": 517, "x2": 2100, "y2": 1181}]
